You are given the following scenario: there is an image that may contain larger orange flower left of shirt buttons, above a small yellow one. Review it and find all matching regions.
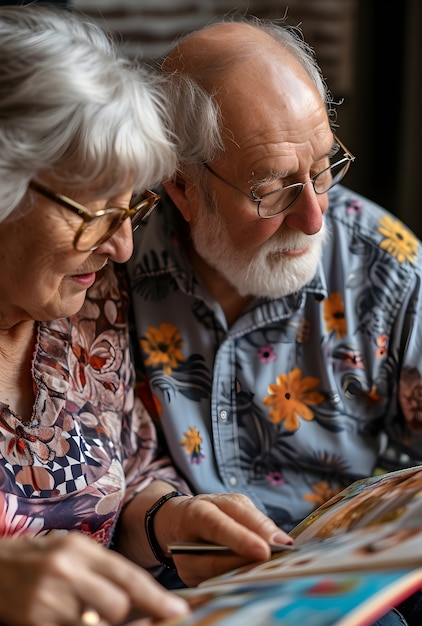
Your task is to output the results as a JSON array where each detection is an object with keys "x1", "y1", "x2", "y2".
[{"x1": 139, "y1": 322, "x2": 185, "y2": 376}]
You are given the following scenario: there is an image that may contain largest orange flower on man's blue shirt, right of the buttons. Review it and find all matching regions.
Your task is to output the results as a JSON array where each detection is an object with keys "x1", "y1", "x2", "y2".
[{"x1": 263, "y1": 367, "x2": 324, "y2": 431}]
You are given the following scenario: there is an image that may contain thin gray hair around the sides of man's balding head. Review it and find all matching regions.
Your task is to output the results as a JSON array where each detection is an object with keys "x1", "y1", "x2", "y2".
[{"x1": 161, "y1": 17, "x2": 335, "y2": 176}]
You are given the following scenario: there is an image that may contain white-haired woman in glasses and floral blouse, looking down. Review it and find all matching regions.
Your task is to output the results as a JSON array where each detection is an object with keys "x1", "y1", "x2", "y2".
[{"x1": 0, "y1": 5, "x2": 287, "y2": 626}]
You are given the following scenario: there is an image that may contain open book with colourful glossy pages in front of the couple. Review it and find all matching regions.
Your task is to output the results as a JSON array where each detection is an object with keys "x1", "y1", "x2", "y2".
[{"x1": 162, "y1": 466, "x2": 422, "y2": 626}]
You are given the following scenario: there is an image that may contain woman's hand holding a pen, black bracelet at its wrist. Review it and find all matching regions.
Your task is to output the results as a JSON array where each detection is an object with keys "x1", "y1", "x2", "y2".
[{"x1": 117, "y1": 482, "x2": 292, "y2": 586}]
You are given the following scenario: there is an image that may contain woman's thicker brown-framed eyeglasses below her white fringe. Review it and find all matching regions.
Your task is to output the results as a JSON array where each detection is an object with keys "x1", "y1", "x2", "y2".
[{"x1": 29, "y1": 180, "x2": 160, "y2": 252}]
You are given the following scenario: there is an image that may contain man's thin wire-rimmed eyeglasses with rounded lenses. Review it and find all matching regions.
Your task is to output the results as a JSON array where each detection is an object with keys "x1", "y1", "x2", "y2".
[{"x1": 204, "y1": 137, "x2": 355, "y2": 219}]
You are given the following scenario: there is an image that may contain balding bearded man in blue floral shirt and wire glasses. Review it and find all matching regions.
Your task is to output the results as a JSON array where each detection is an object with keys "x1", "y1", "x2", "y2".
[{"x1": 129, "y1": 15, "x2": 422, "y2": 623}]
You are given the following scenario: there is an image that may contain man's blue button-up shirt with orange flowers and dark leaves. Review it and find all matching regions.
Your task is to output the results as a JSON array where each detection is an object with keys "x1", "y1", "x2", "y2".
[{"x1": 129, "y1": 186, "x2": 422, "y2": 530}]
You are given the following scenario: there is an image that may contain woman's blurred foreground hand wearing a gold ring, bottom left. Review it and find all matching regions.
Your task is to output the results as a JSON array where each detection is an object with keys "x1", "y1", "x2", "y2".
[{"x1": 0, "y1": 532, "x2": 188, "y2": 626}]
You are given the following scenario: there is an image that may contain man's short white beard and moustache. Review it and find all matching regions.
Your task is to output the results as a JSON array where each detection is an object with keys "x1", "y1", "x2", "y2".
[{"x1": 191, "y1": 200, "x2": 326, "y2": 298}]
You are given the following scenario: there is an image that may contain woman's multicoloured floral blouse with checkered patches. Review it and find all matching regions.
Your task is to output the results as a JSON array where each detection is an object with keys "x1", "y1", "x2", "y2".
[{"x1": 0, "y1": 266, "x2": 182, "y2": 545}]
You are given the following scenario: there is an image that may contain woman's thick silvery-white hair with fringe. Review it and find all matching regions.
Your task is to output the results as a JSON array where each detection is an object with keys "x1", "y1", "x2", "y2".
[{"x1": 0, "y1": 5, "x2": 176, "y2": 221}]
